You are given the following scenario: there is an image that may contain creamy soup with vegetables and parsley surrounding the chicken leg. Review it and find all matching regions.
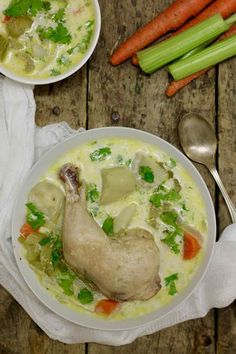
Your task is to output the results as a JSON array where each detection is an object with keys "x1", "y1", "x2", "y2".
[{"x1": 20, "y1": 138, "x2": 208, "y2": 319}]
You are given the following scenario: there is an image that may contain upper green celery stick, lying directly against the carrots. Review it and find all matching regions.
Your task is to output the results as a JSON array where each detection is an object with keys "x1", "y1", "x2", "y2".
[{"x1": 137, "y1": 14, "x2": 229, "y2": 74}]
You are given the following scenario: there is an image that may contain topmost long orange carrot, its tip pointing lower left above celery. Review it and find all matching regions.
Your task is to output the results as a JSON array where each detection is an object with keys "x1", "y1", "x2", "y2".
[{"x1": 110, "y1": 0, "x2": 213, "y2": 65}]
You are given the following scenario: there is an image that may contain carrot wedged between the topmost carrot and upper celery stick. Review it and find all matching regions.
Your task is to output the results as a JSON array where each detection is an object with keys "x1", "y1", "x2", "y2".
[{"x1": 174, "y1": 0, "x2": 236, "y2": 36}]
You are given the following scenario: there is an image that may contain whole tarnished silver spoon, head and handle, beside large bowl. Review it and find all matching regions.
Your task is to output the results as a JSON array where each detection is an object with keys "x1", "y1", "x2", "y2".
[{"x1": 178, "y1": 113, "x2": 236, "y2": 223}]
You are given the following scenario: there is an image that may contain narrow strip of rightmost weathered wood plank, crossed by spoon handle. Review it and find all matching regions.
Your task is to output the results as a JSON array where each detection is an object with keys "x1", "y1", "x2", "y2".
[{"x1": 217, "y1": 59, "x2": 236, "y2": 354}]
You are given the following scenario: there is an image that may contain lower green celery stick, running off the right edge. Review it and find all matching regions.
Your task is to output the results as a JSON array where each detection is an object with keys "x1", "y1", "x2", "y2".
[{"x1": 169, "y1": 35, "x2": 236, "y2": 81}]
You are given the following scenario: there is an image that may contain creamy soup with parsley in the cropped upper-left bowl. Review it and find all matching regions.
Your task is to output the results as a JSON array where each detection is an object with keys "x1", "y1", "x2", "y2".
[{"x1": 0, "y1": 0, "x2": 95, "y2": 78}]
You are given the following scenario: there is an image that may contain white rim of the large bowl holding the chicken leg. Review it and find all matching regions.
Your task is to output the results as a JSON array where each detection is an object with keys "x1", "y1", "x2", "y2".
[{"x1": 12, "y1": 127, "x2": 216, "y2": 330}]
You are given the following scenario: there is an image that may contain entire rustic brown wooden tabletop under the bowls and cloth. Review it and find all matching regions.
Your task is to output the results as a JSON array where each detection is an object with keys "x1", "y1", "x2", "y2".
[{"x1": 0, "y1": 0, "x2": 236, "y2": 354}]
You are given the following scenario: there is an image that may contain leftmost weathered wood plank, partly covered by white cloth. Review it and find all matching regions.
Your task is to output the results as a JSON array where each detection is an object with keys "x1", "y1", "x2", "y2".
[{"x1": 0, "y1": 62, "x2": 87, "y2": 354}]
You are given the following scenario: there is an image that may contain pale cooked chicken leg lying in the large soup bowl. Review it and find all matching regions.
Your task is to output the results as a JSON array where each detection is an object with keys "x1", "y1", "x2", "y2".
[{"x1": 60, "y1": 164, "x2": 161, "y2": 301}]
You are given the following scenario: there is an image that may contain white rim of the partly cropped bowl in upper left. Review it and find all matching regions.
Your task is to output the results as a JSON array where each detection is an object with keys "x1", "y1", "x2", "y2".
[{"x1": 0, "y1": 0, "x2": 101, "y2": 85}]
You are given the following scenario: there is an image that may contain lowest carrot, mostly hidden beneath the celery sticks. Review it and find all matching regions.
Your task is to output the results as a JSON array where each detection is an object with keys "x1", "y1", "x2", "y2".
[{"x1": 166, "y1": 25, "x2": 236, "y2": 97}]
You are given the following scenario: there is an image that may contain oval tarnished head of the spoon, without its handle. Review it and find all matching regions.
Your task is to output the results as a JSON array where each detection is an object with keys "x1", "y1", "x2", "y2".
[{"x1": 178, "y1": 113, "x2": 217, "y2": 165}]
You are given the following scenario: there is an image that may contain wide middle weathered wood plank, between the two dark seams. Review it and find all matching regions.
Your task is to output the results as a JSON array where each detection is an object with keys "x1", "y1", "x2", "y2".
[{"x1": 88, "y1": 0, "x2": 218, "y2": 354}]
